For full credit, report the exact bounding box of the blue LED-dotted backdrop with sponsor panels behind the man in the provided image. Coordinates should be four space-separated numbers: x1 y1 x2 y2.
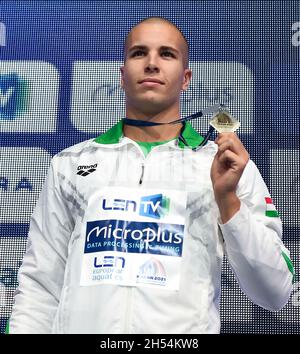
0 0 300 333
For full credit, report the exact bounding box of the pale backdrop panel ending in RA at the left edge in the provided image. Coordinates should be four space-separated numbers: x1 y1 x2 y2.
0 147 51 223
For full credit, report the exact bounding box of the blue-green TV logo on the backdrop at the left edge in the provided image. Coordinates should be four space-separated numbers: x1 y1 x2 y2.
0 73 29 120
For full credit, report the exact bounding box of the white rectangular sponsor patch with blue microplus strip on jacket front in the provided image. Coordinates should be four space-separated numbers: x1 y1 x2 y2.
80 187 187 290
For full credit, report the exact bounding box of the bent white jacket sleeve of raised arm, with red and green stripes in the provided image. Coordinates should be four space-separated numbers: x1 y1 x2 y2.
219 160 294 311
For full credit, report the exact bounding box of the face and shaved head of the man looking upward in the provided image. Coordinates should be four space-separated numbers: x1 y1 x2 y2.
120 22 191 114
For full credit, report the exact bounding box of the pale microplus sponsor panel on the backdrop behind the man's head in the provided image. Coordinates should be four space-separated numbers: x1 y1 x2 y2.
71 61 253 133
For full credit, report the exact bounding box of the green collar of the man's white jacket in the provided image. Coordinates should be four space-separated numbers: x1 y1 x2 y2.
94 120 204 148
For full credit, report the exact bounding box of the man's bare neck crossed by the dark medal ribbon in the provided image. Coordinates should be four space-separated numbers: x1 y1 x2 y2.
123 104 182 142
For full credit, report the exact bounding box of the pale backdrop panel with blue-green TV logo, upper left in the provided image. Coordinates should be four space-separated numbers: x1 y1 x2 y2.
0 61 59 132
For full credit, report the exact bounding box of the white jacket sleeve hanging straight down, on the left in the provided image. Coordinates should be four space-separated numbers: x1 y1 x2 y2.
9 157 73 333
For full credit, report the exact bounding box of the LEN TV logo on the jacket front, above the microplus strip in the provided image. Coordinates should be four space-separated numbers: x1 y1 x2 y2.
101 194 170 219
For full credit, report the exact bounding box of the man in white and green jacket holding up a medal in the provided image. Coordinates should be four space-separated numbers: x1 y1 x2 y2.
10 18 293 333
